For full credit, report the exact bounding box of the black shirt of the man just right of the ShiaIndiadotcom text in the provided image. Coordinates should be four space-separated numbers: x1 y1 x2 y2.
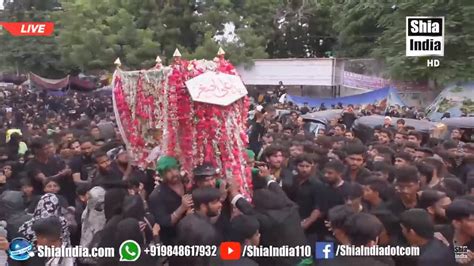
418 239 456 266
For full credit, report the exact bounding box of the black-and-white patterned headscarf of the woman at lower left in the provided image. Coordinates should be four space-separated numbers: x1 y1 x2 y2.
18 193 71 246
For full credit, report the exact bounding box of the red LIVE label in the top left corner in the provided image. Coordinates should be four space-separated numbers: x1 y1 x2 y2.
0 22 54 36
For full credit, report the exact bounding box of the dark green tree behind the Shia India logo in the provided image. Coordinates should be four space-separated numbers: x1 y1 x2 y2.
372 1 474 85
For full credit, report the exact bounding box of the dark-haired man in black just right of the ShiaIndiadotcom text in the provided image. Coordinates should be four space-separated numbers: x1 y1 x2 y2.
400 209 456 266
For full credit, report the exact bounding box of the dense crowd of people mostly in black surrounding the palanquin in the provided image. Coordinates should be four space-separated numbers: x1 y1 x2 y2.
0 85 474 266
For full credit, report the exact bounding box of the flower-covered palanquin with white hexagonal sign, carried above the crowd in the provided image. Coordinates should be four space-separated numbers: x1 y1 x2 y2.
113 52 251 197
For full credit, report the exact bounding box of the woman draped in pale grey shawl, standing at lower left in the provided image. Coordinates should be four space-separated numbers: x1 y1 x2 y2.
81 187 105 264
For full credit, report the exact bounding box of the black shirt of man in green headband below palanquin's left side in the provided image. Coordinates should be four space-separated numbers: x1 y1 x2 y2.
149 184 181 245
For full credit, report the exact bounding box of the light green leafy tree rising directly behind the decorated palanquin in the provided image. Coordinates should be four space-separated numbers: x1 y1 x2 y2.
59 0 266 71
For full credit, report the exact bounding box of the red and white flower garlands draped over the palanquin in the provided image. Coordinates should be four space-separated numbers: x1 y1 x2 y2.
114 57 251 198
